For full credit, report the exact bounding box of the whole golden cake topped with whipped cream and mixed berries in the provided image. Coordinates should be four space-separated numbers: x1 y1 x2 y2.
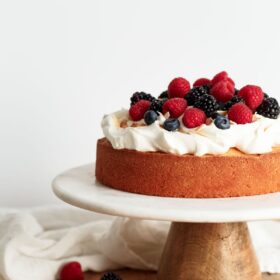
95 71 280 198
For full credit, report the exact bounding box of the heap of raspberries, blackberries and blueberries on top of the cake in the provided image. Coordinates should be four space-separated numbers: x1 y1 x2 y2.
129 71 280 131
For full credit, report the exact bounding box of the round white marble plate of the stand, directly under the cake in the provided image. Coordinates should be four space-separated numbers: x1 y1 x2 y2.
52 163 280 223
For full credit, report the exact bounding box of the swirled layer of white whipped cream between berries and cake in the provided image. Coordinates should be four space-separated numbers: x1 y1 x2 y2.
102 110 280 156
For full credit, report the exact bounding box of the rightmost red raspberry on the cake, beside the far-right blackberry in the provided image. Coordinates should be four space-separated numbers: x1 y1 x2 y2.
238 85 264 110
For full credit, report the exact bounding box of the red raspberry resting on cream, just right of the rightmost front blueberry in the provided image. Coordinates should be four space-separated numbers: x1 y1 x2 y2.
228 103 253 124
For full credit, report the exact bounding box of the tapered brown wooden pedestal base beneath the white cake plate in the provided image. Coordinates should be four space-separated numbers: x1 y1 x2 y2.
158 223 261 280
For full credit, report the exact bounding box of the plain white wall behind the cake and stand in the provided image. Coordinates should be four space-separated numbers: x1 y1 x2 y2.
0 0 280 207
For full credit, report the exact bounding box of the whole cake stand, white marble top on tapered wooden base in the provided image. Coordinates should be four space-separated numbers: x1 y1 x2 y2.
53 164 280 280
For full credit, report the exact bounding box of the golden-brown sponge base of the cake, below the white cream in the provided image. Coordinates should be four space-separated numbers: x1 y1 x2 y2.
95 138 280 198
